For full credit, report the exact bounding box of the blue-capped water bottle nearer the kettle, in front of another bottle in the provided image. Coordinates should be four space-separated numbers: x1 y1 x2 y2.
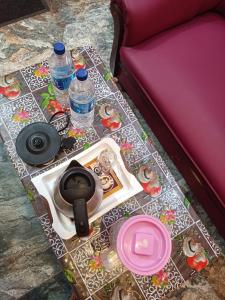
69 69 95 128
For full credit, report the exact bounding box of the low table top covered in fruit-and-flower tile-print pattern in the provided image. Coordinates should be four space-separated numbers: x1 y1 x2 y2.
0 47 220 300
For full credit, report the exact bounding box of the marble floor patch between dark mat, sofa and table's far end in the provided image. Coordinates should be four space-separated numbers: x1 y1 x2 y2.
0 0 113 75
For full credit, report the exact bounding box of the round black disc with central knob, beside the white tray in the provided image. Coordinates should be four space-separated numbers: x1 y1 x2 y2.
16 122 61 166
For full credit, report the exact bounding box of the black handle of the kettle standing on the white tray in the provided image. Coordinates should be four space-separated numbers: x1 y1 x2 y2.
73 199 89 237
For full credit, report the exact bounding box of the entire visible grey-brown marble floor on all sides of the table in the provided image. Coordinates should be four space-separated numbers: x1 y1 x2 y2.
0 0 225 300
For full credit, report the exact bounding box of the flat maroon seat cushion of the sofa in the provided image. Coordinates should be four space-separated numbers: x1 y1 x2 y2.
120 13 225 207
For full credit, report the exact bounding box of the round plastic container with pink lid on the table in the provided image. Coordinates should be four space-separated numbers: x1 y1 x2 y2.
103 215 172 276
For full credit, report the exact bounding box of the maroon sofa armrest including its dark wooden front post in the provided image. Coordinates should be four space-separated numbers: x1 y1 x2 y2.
110 0 222 76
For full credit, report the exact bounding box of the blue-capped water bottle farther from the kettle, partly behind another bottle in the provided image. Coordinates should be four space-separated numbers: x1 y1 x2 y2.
49 42 75 106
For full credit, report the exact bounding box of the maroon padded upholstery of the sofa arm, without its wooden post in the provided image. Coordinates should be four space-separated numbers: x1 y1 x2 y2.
111 0 221 46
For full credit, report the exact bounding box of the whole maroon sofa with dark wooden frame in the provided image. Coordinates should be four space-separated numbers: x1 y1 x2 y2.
111 0 225 236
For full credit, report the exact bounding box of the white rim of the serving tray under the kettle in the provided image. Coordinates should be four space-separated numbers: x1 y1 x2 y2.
31 138 143 240
